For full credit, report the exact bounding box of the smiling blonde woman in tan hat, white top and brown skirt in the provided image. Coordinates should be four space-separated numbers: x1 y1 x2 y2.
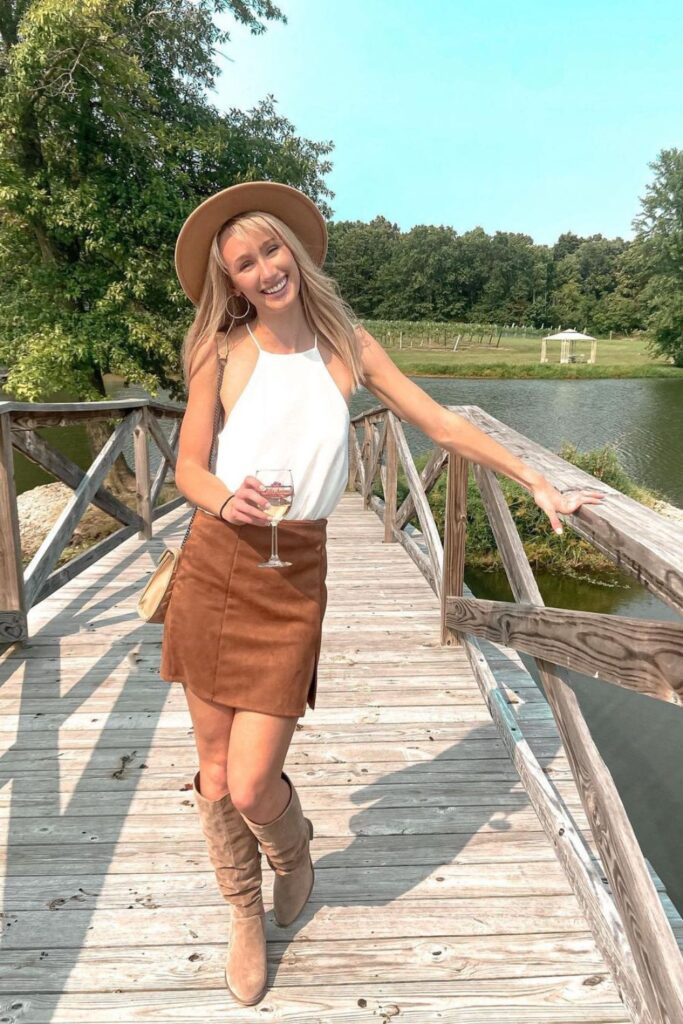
161 181 600 1005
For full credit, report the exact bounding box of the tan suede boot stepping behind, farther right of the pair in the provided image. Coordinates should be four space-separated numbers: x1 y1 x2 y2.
242 772 315 928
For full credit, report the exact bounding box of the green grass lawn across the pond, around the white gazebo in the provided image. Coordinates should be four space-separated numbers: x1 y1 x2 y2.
378 333 683 379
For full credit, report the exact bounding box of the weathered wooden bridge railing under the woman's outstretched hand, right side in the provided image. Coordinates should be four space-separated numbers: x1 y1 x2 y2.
348 406 683 1024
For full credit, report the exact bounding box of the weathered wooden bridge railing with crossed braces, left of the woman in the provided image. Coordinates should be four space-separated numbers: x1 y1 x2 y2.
0 398 185 644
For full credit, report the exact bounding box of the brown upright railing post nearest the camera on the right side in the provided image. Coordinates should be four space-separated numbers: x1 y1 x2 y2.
441 451 468 647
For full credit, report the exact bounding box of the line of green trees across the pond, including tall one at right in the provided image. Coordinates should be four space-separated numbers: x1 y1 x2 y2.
329 150 683 366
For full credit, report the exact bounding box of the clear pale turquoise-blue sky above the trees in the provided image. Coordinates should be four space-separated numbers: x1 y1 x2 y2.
209 0 683 244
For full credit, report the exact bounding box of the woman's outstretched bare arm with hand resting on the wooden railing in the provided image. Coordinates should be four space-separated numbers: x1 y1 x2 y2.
357 328 604 534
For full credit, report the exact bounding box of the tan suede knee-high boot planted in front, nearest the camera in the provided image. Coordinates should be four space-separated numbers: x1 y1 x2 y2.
193 772 268 1006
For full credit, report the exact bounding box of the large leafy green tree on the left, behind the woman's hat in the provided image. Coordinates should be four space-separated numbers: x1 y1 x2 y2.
0 0 332 487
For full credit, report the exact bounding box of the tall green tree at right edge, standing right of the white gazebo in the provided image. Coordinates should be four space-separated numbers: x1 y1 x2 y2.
629 148 683 367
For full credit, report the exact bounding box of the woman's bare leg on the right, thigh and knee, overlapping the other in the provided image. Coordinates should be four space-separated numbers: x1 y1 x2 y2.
227 708 298 823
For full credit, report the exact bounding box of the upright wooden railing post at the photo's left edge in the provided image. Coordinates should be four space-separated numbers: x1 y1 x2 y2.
0 413 29 644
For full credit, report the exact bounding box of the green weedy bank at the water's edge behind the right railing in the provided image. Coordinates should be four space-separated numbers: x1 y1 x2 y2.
373 442 664 586
